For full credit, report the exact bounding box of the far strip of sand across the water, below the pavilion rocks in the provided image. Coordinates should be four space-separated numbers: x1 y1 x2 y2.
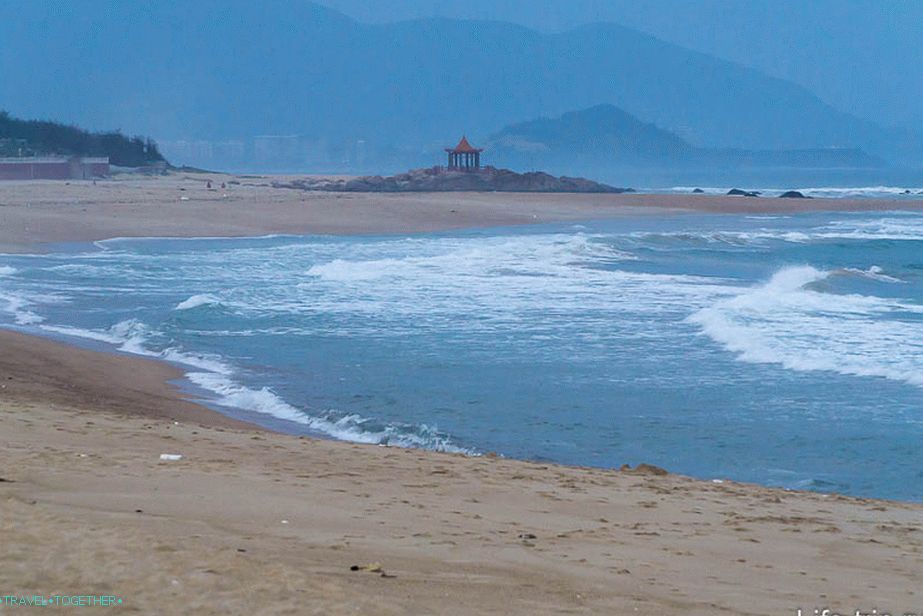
0 173 923 253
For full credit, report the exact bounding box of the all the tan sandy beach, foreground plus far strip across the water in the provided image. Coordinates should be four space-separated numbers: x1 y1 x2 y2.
0 174 923 616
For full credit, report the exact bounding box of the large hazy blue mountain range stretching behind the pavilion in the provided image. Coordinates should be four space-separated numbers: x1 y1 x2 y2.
0 0 923 171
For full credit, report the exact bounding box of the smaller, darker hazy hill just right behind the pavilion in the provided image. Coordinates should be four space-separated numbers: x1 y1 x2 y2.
484 105 884 174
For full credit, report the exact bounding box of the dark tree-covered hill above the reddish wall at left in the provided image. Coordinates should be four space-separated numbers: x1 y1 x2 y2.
0 111 164 167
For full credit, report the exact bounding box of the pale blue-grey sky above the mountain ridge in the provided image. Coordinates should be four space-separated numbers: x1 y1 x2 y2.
319 0 923 130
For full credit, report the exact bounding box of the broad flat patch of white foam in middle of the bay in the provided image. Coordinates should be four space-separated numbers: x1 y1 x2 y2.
296 234 727 337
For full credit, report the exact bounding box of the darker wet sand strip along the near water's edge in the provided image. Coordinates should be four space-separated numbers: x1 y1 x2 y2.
0 326 923 511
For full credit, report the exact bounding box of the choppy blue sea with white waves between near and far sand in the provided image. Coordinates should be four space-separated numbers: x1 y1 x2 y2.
0 195 923 501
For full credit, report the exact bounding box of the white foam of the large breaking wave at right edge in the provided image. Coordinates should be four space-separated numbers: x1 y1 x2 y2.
688 266 923 386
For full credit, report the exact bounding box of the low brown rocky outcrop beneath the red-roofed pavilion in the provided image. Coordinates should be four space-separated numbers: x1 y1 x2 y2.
273 167 634 193
